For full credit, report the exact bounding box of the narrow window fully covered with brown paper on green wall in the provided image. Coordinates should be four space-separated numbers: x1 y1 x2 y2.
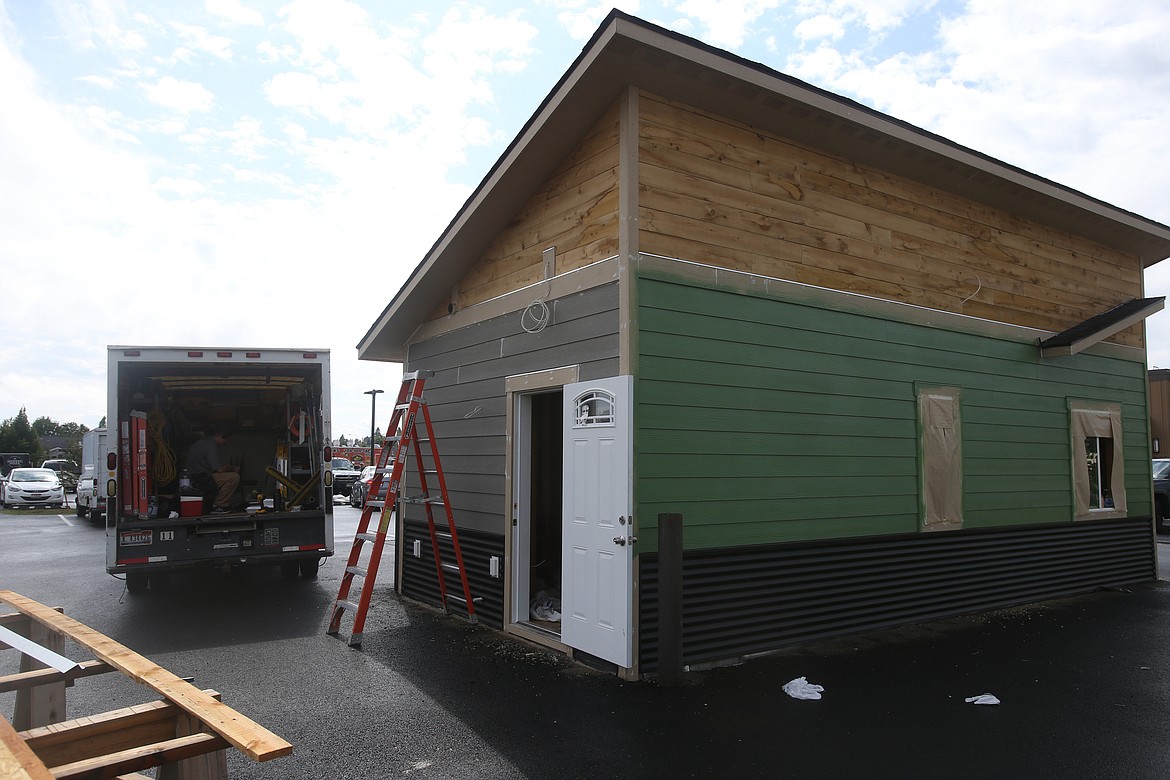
918 387 963 531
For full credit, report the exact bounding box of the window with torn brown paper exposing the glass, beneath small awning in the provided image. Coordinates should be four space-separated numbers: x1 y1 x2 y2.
1068 401 1127 520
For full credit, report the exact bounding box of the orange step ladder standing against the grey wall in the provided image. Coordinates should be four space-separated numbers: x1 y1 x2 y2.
325 371 481 647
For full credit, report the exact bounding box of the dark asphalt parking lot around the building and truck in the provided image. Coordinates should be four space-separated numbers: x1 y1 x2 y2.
0 506 1170 780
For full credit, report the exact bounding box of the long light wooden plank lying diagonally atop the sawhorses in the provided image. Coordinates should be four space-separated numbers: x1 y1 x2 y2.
0 591 293 771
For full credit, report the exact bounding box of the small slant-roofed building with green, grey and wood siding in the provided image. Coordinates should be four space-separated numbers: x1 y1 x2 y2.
359 12 1170 678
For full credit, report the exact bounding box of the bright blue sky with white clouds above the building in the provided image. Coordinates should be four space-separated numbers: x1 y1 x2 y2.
0 0 1170 436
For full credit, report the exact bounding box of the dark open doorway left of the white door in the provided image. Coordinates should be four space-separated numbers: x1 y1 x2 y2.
512 388 564 637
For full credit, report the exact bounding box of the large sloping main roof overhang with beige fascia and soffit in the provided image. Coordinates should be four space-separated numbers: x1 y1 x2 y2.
358 11 1170 361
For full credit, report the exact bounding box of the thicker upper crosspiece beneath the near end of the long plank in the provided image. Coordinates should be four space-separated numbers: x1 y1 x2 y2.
20 690 220 766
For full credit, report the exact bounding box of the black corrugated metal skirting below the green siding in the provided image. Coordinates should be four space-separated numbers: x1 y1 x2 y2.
638 517 1157 674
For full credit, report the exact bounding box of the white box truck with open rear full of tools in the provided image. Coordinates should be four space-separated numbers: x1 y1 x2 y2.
105 346 333 593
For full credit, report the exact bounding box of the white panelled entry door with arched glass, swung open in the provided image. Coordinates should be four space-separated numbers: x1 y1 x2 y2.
560 377 633 667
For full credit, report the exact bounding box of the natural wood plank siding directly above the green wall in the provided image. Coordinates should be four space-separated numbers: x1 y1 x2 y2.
638 92 1142 346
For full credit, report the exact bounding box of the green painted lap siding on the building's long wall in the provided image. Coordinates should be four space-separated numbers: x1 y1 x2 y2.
634 269 1150 551
